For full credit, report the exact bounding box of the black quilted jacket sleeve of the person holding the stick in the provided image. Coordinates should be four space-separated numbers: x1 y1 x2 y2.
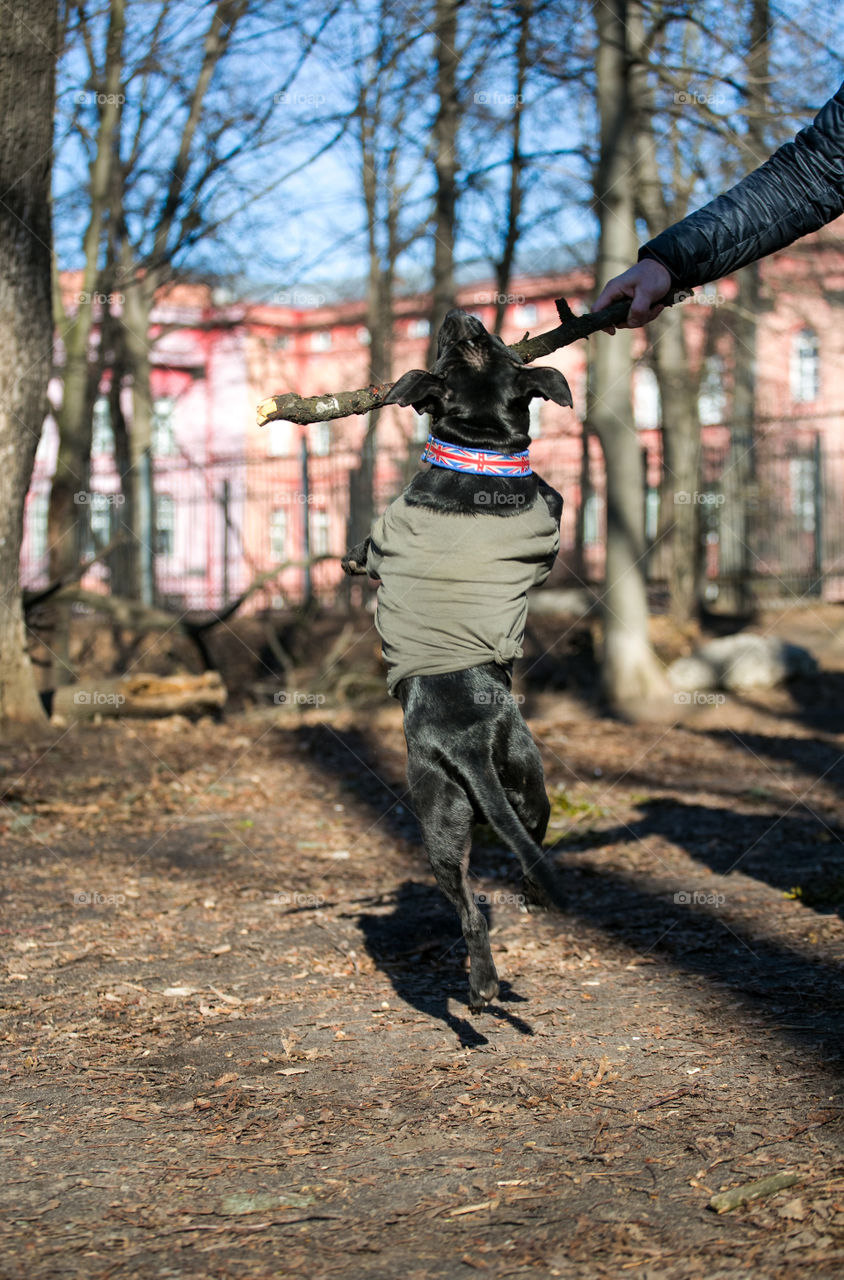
639 84 844 291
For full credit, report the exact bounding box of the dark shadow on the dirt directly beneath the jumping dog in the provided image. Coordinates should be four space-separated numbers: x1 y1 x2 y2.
356 879 534 1048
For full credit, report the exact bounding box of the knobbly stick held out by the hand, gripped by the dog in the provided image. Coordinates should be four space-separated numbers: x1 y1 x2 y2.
257 298 630 426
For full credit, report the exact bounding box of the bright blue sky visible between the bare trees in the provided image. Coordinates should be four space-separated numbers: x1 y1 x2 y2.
55 0 844 303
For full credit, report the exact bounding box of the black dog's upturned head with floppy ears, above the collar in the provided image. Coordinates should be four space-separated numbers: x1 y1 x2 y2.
384 310 572 453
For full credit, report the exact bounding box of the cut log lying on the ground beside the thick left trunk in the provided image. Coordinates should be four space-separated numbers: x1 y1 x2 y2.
53 671 227 721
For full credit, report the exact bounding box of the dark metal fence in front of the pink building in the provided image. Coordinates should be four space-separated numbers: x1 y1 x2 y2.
22 425 844 611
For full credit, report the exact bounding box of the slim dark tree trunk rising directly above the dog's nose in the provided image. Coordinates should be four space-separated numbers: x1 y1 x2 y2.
428 0 460 367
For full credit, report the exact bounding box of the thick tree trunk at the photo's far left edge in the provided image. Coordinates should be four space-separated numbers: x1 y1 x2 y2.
0 0 58 739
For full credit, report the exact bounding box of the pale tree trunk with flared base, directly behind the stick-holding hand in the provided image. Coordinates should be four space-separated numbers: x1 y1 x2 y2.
589 0 667 714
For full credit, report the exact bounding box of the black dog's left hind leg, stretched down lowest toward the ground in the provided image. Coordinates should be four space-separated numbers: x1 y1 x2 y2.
407 765 498 1014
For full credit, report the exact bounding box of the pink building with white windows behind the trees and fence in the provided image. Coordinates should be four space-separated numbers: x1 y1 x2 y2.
23 220 844 609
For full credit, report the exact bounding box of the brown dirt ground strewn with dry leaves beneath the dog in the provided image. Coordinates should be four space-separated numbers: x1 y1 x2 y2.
0 609 844 1280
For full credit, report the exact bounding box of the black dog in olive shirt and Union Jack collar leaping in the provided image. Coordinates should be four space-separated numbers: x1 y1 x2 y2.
343 311 571 1012
